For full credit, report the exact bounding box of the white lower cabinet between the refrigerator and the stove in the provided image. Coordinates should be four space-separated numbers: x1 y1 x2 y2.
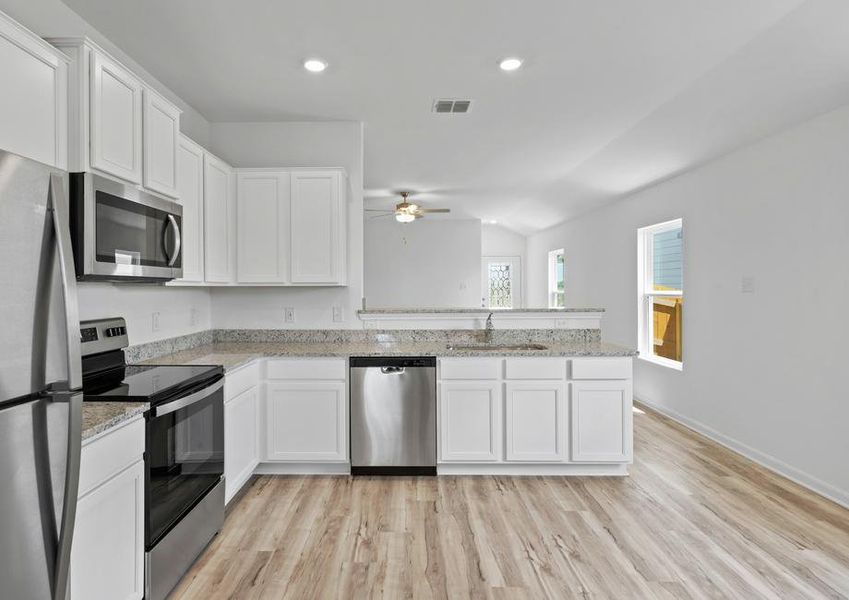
71 418 145 600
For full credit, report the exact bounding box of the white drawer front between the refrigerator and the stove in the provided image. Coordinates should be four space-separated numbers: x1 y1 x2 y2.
78 415 144 496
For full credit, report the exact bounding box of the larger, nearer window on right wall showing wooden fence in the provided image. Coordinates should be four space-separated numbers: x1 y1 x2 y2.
637 219 684 370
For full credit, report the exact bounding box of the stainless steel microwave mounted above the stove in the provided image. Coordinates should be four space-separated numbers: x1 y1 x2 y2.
69 173 183 281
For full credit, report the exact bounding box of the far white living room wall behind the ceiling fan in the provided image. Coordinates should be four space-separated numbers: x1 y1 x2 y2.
365 217 481 308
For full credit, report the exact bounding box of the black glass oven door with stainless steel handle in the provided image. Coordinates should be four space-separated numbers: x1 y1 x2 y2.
145 377 224 550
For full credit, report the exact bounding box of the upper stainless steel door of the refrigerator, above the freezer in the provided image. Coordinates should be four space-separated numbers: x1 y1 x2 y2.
0 151 79 406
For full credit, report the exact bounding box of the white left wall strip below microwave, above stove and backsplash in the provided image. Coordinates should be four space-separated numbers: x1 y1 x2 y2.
77 282 212 344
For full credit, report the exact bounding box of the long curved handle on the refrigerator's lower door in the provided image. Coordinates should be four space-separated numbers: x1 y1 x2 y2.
53 393 83 600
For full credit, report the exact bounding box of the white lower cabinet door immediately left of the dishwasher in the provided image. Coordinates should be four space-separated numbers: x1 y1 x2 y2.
266 381 348 462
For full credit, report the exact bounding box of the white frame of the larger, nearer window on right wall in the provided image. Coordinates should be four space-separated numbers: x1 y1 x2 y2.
637 218 686 371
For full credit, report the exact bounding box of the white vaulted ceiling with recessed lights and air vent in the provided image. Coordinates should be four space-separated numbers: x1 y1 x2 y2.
58 0 849 233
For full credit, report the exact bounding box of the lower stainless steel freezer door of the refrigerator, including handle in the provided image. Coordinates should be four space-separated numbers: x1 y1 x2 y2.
0 394 82 600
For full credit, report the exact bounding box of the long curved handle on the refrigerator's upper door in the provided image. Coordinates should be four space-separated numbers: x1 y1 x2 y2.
47 174 83 390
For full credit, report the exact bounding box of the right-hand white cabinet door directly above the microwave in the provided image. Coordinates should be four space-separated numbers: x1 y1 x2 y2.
142 88 180 198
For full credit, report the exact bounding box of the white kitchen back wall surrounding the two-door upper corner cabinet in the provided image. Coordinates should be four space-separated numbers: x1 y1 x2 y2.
210 121 363 329
